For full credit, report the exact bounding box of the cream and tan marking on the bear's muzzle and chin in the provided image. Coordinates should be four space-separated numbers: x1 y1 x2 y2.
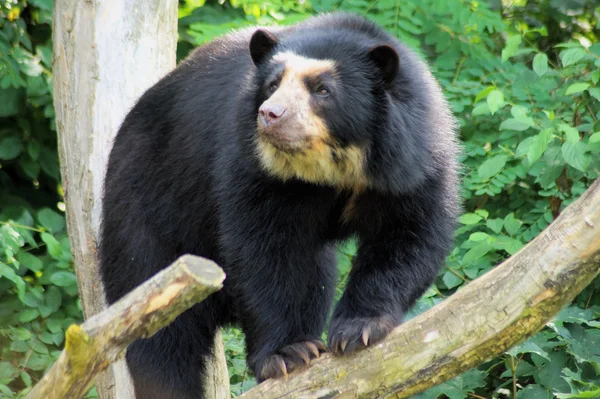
257 52 366 188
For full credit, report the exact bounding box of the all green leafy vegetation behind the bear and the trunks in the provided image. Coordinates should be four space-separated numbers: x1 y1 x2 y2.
0 0 600 399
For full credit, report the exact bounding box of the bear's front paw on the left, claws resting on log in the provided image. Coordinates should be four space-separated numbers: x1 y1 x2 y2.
256 339 327 382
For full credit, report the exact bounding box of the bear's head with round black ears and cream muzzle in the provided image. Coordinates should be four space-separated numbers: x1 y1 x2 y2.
250 29 399 190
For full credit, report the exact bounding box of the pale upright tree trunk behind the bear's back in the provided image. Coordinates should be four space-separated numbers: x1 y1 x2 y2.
53 0 229 399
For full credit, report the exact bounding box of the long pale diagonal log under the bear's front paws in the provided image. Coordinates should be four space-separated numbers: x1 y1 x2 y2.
240 180 600 399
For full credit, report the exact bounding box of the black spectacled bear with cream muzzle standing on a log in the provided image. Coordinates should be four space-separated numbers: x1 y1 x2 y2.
100 13 459 399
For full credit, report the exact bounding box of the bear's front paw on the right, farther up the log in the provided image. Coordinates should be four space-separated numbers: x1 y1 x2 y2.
327 315 400 354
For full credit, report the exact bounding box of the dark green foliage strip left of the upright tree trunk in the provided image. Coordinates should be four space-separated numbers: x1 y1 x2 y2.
0 0 90 398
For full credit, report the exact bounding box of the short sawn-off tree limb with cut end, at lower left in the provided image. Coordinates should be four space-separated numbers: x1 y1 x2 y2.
22 255 225 399
